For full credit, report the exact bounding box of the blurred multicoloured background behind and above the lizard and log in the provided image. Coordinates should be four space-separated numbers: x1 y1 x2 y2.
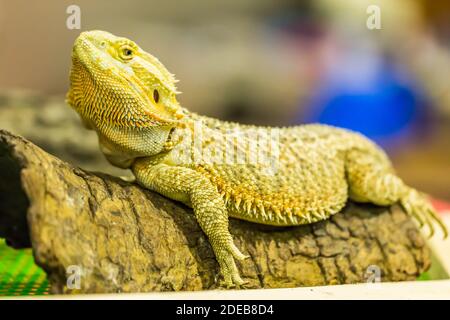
0 0 450 200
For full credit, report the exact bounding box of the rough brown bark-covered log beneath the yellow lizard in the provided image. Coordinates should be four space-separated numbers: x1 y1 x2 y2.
0 130 430 292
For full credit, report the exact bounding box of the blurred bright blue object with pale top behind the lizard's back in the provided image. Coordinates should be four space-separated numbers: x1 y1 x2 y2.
306 50 425 146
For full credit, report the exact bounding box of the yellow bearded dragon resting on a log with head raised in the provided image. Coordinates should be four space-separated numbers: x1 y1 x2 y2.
67 31 447 286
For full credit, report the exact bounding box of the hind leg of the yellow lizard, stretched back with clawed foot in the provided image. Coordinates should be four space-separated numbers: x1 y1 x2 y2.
346 152 448 238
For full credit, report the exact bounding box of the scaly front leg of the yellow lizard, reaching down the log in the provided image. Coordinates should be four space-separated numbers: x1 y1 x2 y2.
132 158 246 287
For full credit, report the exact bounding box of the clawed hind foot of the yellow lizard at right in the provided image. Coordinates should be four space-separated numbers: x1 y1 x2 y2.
400 187 448 239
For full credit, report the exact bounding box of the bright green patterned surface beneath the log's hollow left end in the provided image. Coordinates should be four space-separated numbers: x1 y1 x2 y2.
0 239 49 296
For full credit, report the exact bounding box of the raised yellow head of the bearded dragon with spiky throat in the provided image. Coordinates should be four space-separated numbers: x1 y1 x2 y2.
67 31 182 129
